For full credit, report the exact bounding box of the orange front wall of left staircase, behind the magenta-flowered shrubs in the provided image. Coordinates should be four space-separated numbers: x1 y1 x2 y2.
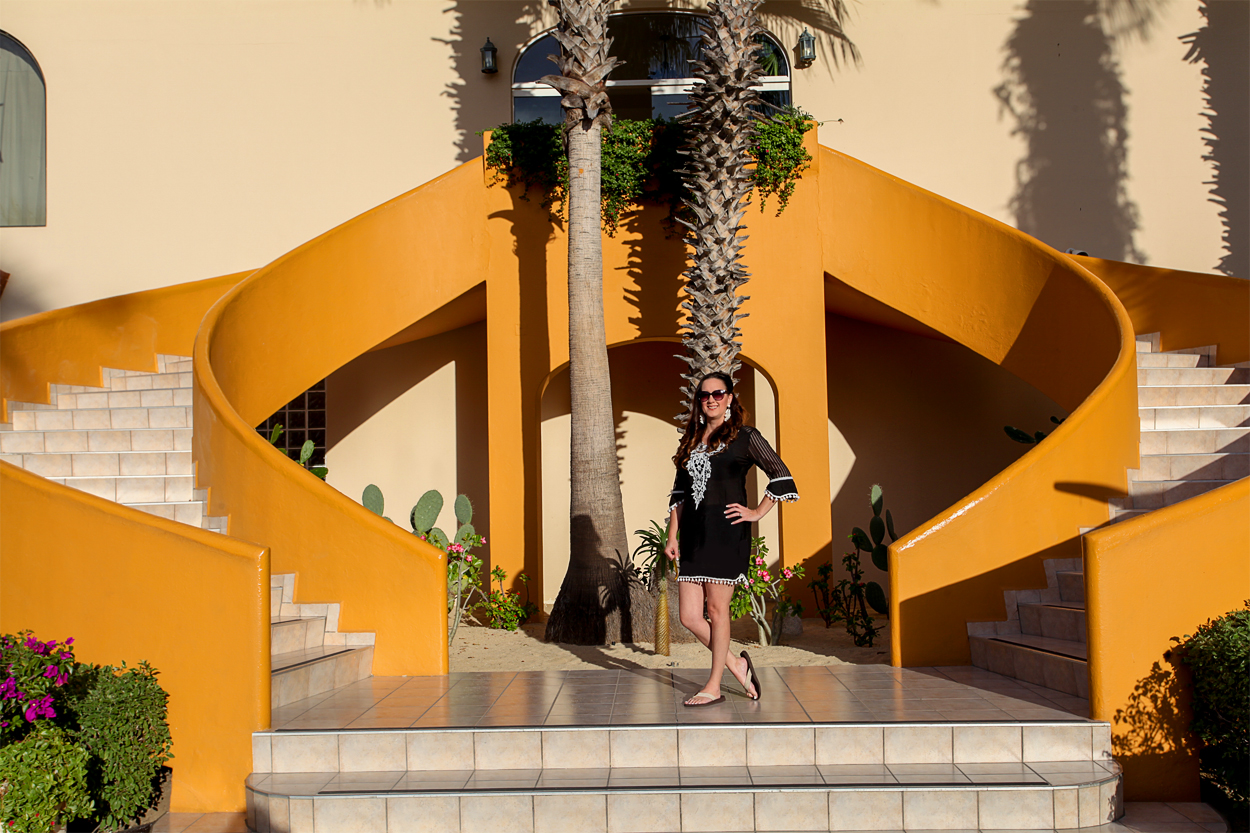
0 463 269 813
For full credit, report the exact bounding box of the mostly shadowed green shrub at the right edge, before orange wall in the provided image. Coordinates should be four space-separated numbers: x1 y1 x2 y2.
1176 600 1250 802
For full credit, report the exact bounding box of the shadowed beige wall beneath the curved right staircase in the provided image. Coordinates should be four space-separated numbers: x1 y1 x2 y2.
825 314 1078 584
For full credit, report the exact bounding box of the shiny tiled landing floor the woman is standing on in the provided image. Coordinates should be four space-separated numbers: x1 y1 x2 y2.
273 665 1088 730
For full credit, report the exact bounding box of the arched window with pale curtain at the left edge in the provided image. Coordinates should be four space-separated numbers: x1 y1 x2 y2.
0 31 48 226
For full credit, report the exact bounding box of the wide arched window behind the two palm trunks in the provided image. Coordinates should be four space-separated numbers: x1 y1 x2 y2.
513 11 790 124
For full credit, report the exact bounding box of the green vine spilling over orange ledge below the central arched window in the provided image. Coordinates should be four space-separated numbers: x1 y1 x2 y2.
475 108 814 236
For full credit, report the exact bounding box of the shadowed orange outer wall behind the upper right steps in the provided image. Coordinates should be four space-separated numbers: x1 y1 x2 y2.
1074 258 1250 364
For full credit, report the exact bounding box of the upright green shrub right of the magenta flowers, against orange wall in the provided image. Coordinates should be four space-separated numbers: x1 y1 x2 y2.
75 663 173 830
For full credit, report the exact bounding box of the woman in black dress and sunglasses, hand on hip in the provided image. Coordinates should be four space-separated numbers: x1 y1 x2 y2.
664 373 799 705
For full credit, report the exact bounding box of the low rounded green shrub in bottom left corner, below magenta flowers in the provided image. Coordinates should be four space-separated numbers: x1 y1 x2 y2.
0 722 93 833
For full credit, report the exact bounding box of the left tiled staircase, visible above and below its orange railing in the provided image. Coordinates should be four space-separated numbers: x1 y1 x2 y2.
0 355 374 707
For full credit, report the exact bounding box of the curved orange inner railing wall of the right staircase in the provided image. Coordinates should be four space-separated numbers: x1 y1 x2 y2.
815 148 1138 665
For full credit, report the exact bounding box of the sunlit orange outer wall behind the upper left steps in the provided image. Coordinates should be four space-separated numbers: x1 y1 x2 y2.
0 271 249 423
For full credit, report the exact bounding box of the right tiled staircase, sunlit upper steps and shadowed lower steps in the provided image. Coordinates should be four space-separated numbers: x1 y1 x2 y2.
968 333 1250 698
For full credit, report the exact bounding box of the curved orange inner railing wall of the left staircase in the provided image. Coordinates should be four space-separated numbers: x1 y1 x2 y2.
193 160 489 674
